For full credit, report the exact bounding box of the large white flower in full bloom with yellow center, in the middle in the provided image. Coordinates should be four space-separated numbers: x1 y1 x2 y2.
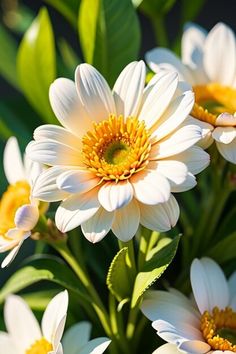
26 61 209 242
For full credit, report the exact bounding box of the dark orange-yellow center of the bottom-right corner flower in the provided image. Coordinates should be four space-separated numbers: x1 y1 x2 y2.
201 307 236 353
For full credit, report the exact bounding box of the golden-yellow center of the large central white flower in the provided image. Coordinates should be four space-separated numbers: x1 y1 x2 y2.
82 115 151 182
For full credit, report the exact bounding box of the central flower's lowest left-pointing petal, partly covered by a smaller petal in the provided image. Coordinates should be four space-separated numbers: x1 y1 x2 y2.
32 166 68 202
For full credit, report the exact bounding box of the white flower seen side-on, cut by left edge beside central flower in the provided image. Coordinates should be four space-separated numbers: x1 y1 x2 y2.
0 137 42 267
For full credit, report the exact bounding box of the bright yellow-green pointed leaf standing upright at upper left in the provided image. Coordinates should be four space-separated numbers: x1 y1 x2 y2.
17 9 57 123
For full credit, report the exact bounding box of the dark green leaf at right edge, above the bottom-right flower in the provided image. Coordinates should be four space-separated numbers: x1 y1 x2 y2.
207 232 236 264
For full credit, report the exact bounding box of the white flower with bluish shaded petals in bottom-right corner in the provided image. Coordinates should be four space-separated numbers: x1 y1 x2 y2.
142 258 236 354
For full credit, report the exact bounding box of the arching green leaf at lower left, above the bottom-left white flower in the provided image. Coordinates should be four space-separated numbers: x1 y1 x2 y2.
0 256 86 303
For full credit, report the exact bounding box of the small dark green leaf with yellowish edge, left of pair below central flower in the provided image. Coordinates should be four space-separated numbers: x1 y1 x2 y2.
107 247 134 301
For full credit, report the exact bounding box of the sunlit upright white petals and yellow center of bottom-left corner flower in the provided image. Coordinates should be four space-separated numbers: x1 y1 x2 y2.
0 291 68 354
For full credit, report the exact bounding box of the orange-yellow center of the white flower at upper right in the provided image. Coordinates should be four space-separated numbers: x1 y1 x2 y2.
191 83 236 125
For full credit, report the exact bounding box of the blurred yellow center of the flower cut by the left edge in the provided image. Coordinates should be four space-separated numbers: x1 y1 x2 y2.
0 181 30 236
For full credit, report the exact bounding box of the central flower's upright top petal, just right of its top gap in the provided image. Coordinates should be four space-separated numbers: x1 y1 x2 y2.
113 60 146 117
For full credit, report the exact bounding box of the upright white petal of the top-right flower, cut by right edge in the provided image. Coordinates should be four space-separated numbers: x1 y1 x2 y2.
204 23 236 86
